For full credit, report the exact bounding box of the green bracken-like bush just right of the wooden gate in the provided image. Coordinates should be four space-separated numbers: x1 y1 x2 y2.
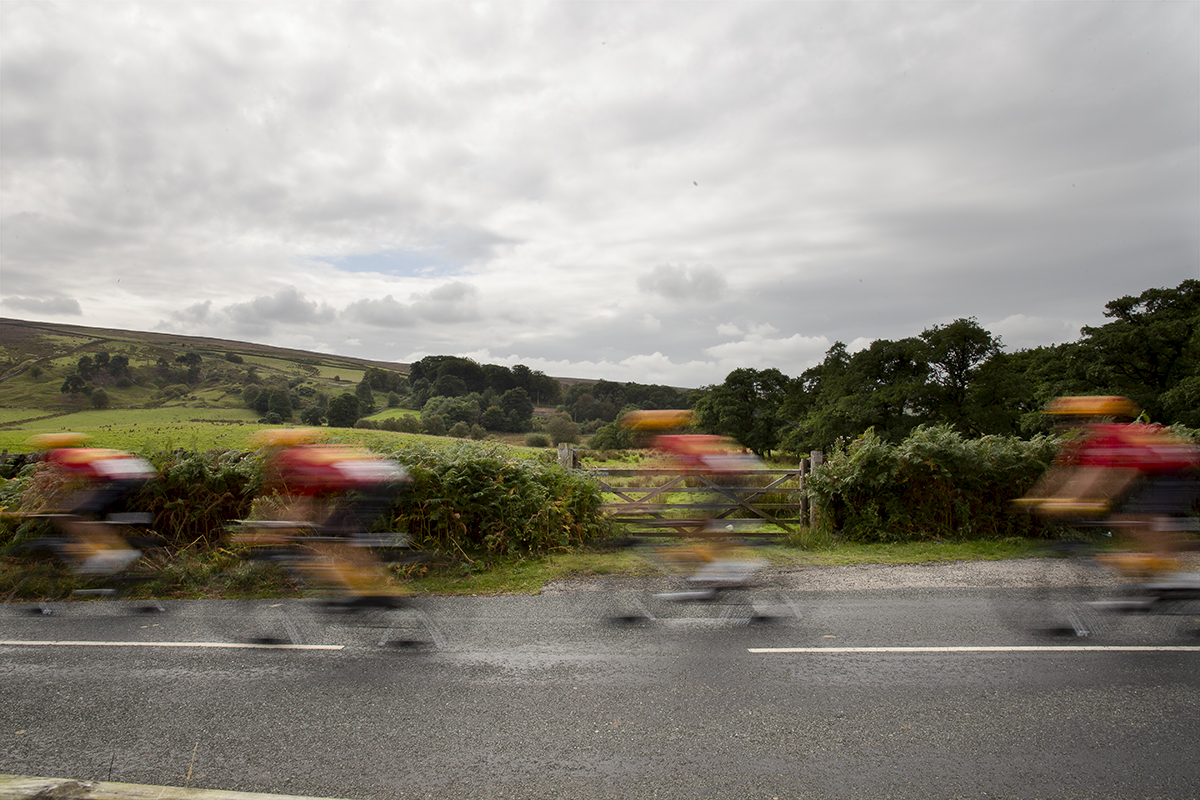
809 426 1058 542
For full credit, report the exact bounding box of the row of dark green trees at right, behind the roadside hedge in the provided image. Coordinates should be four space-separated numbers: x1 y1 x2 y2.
695 281 1200 455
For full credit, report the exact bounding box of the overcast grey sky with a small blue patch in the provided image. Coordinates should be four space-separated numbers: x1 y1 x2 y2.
0 0 1200 386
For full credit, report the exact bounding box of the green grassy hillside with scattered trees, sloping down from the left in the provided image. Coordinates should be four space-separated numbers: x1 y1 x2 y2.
0 319 420 450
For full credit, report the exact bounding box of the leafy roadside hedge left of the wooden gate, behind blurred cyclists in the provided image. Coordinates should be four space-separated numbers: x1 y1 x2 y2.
0 441 606 558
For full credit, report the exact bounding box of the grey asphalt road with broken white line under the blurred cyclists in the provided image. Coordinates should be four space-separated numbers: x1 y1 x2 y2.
0 588 1200 800
